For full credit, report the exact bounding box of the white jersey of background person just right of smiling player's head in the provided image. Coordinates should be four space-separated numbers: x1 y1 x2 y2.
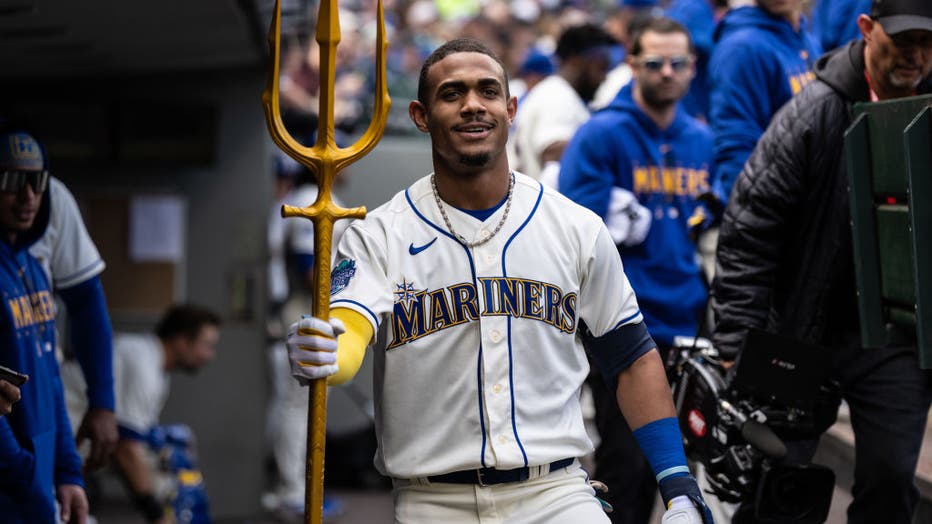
510 75 590 179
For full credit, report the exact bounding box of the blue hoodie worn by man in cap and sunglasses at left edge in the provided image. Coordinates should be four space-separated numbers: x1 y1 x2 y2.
0 199 84 524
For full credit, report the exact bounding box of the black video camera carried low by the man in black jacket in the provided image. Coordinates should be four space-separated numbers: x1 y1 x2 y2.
667 331 837 523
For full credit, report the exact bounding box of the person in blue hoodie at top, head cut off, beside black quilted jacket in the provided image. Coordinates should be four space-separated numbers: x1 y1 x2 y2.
709 0 822 202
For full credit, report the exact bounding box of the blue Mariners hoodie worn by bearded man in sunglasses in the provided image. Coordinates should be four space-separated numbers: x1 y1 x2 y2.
559 84 713 345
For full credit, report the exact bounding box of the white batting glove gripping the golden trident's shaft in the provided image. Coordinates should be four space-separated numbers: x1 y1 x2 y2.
285 317 346 386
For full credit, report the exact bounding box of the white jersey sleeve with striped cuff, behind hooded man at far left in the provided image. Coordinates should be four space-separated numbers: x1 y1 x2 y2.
29 177 104 289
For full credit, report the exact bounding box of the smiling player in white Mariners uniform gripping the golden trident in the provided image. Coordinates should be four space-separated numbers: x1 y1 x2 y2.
288 39 711 523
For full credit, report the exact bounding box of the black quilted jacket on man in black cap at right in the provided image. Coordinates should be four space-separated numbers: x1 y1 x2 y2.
712 41 932 357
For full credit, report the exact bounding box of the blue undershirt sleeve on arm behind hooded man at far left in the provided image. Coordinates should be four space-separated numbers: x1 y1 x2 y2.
58 276 116 411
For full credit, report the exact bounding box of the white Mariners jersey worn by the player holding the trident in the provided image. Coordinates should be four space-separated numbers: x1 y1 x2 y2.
331 173 642 478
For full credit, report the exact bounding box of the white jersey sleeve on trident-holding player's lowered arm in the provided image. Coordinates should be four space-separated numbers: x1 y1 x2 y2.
579 225 644 337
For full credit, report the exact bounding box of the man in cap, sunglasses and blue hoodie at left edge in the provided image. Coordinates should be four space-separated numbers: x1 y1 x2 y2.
0 127 88 524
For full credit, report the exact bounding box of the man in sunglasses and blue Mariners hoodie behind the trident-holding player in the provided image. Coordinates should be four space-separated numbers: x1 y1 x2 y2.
559 18 713 523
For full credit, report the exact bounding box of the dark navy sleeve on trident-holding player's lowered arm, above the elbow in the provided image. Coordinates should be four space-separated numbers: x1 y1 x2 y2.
580 322 657 392
